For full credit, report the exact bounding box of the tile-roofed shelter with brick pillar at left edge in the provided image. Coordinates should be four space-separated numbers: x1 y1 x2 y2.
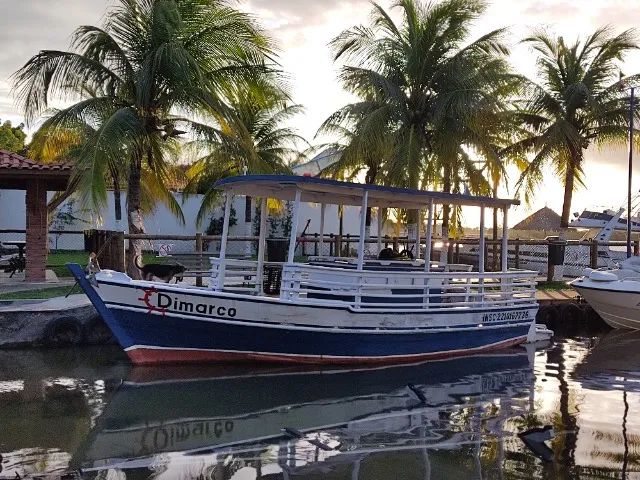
0 150 71 282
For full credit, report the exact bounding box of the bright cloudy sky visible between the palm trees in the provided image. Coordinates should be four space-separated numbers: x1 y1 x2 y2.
0 0 640 224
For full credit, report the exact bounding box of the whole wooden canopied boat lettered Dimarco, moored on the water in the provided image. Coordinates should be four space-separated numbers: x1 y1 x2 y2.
68 175 538 364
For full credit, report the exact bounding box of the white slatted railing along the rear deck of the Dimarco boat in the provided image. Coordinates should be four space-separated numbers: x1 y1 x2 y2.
280 264 537 310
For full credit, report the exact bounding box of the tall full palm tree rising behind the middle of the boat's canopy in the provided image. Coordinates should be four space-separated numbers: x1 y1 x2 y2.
332 0 514 236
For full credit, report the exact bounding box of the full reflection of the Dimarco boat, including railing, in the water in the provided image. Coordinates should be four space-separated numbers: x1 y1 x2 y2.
74 348 534 479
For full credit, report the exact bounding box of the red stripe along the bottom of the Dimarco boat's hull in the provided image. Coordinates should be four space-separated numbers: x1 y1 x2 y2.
127 337 526 365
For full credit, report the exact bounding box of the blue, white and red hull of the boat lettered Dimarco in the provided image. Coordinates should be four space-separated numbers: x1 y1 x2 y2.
67 266 537 364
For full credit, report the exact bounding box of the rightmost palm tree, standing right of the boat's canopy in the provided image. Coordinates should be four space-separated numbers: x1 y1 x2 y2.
507 27 640 228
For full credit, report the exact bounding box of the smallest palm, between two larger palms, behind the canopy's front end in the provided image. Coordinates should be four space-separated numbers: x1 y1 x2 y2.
185 85 306 225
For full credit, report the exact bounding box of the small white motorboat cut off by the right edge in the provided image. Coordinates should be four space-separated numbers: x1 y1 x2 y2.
570 257 640 330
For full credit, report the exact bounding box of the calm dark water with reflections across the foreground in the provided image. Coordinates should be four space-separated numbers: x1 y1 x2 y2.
0 332 640 480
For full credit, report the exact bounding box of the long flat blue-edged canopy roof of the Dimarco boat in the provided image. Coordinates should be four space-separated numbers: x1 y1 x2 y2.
214 175 520 209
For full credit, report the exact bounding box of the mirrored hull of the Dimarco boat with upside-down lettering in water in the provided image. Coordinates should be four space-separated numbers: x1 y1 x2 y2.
71 347 534 478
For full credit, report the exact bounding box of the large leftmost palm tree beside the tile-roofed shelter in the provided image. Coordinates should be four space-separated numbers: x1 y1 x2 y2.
14 0 271 275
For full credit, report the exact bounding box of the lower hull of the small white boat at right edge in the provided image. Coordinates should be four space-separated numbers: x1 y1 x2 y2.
571 279 640 330
